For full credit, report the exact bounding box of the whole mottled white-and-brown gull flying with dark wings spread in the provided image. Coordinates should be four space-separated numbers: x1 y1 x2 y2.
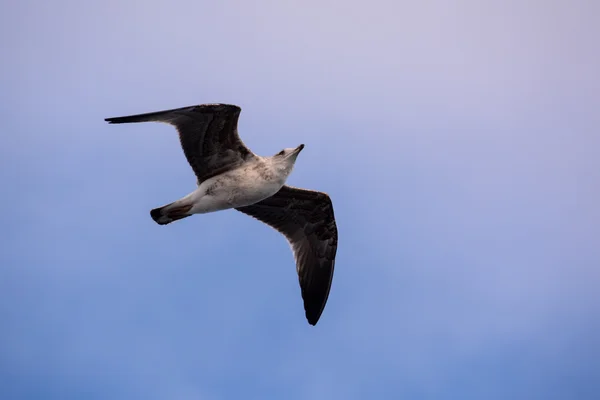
105 104 338 325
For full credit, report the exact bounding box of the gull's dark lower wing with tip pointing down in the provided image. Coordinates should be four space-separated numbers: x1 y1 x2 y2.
237 186 338 325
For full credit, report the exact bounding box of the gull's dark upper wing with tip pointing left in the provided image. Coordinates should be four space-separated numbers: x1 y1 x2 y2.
105 104 254 184
